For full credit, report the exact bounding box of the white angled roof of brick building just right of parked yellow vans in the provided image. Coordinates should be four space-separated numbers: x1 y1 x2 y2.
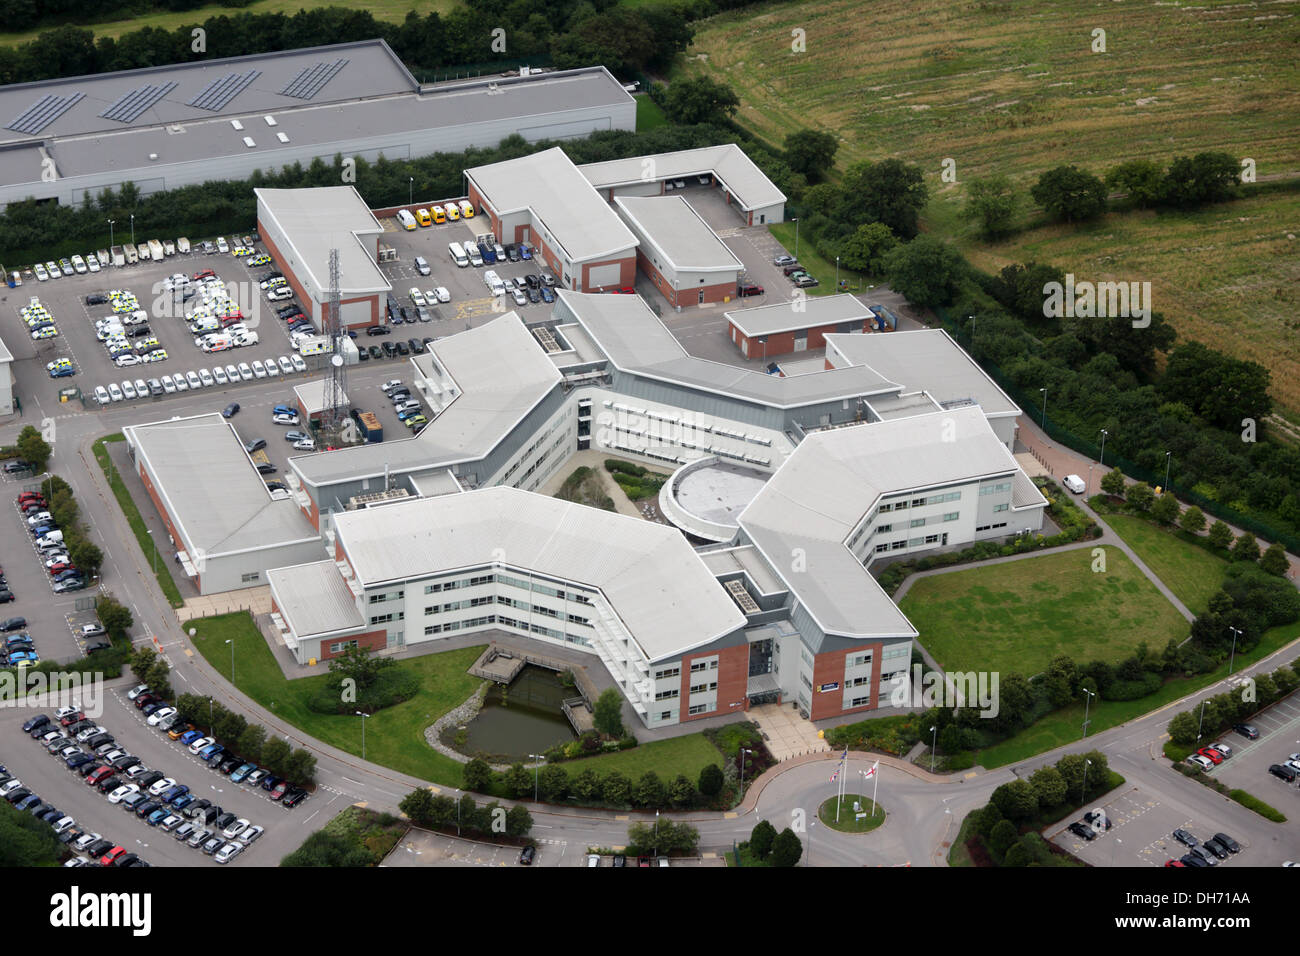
465 146 637 263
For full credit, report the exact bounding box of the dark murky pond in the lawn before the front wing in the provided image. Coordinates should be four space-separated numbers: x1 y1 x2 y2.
442 665 577 763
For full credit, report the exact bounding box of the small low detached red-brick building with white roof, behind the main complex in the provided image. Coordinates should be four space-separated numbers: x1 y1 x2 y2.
723 295 875 368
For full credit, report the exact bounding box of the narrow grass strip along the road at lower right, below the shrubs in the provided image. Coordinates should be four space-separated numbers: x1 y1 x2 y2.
975 622 1300 770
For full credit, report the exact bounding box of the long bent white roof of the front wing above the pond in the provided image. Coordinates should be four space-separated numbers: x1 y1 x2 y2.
334 486 745 661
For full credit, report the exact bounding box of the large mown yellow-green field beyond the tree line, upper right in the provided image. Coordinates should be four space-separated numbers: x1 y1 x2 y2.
681 0 1300 410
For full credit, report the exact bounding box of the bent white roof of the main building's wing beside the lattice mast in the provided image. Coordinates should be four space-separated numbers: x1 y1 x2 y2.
291 316 561 485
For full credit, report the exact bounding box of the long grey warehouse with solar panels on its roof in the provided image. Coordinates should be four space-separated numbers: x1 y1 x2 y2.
0 39 636 207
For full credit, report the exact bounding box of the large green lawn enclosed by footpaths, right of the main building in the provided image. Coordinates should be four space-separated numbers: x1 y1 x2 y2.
900 548 1187 676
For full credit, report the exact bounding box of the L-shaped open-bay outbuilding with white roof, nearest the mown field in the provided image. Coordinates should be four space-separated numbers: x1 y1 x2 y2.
579 143 785 226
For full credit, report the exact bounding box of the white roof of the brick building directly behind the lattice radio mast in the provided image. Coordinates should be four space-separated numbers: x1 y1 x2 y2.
254 186 393 293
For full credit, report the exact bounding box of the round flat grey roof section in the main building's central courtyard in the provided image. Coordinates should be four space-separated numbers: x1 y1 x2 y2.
659 455 771 541
